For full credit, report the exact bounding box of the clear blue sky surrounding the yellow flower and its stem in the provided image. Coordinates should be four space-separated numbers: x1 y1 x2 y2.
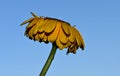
0 0 120 76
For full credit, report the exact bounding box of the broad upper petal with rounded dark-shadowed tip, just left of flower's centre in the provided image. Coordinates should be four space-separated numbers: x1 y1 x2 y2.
45 20 57 33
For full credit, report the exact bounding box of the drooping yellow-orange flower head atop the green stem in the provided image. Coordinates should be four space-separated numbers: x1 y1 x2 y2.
21 13 85 53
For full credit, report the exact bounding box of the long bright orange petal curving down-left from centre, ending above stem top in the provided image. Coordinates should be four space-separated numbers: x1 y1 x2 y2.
48 22 61 42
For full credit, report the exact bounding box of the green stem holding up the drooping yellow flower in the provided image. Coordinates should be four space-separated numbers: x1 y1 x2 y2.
39 43 57 76
